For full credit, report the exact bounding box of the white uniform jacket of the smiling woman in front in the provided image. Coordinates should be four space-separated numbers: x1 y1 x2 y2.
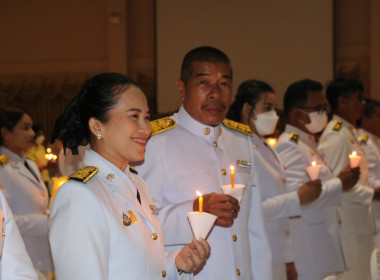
49 149 187 280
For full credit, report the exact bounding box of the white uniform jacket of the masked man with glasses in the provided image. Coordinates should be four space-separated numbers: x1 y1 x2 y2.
275 125 345 275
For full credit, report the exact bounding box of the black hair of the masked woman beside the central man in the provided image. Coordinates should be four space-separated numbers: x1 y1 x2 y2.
227 80 274 122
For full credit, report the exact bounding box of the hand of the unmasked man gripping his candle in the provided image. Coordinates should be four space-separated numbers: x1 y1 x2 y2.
193 193 240 227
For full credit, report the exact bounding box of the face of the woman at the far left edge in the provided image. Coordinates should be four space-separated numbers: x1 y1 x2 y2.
1 114 35 155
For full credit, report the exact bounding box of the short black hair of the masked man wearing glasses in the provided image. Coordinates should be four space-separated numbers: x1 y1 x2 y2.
284 79 323 118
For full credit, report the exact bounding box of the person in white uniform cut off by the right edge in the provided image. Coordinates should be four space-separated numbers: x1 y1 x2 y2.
359 99 380 249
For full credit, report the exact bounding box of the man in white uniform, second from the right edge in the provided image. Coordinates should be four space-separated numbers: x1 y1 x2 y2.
318 78 374 280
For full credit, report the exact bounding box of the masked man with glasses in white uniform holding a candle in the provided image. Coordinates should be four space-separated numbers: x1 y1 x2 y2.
276 79 360 280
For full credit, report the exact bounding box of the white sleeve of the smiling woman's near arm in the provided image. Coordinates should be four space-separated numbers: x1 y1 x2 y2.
49 182 110 280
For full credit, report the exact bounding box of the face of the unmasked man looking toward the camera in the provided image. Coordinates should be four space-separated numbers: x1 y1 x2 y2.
177 61 232 125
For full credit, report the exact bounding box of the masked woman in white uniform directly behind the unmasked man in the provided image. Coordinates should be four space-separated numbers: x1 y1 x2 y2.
227 80 330 280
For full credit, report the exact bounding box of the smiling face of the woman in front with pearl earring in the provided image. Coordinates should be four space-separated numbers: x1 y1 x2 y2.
94 86 152 169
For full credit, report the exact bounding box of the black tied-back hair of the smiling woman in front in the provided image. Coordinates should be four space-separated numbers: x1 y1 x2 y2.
51 73 137 154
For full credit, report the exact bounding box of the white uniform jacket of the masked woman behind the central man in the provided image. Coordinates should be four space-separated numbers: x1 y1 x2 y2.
250 133 301 264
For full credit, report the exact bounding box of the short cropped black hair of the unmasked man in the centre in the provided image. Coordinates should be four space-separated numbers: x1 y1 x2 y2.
181 46 232 84
